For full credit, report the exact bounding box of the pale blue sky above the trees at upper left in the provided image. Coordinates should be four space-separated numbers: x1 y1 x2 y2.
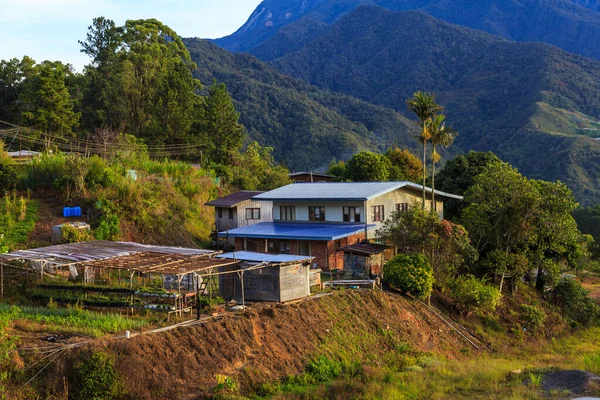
0 0 261 71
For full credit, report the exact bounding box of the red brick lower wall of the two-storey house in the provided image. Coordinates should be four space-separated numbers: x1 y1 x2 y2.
235 232 365 271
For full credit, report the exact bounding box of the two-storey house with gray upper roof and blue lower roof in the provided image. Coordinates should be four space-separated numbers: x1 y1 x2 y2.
219 182 462 270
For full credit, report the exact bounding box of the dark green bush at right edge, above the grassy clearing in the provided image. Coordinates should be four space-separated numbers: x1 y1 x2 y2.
552 277 600 325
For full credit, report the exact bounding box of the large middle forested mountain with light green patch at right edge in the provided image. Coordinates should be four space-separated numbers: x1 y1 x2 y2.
273 6 600 204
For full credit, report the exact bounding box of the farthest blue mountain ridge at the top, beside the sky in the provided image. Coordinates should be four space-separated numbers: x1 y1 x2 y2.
215 0 600 60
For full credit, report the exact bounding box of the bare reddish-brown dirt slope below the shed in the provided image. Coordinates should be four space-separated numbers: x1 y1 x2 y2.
46 291 480 399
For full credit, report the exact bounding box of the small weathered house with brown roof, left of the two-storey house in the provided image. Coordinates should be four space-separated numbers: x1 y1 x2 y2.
206 190 273 244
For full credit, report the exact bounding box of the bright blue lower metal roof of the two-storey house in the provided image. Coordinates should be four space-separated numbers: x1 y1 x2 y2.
219 222 375 241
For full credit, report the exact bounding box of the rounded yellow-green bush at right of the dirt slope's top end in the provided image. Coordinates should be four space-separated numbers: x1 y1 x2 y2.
447 275 501 315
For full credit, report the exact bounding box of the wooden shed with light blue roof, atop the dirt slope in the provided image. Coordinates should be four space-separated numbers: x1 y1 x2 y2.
217 251 313 303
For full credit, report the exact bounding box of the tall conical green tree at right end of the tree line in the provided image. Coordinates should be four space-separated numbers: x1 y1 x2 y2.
201 82 245 165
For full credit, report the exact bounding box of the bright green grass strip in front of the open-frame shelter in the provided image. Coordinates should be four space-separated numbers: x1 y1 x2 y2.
0 304 148 337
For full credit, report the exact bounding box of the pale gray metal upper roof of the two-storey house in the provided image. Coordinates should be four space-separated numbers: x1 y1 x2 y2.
254 181 462 201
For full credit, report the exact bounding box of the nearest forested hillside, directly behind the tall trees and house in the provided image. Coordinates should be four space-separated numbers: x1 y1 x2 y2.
184 39 417 170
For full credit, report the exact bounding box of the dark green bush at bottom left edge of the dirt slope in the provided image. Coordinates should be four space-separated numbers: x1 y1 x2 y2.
74 352 124 400
